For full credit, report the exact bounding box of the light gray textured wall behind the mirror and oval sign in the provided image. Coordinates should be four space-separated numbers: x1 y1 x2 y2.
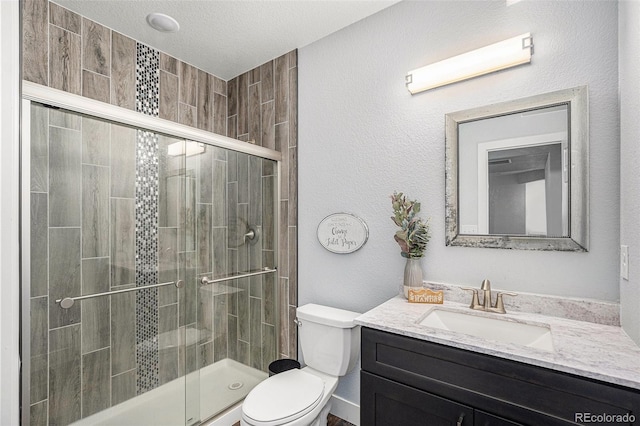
299 1 620 401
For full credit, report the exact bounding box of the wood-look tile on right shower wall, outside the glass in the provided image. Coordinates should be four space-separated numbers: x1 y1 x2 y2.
227 50 298 358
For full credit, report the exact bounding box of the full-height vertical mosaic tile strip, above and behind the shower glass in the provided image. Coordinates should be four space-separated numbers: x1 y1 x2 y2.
135 43 160 394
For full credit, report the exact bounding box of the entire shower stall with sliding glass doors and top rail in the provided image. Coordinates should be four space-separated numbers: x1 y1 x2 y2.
21 85 281 425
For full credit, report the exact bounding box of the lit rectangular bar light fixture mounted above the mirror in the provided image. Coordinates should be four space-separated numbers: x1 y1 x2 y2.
405 33 533 94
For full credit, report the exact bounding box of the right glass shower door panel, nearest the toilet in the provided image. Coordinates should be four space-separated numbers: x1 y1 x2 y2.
192 146 278 419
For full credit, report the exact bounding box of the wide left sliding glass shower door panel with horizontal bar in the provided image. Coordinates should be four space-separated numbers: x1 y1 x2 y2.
25 104 194 425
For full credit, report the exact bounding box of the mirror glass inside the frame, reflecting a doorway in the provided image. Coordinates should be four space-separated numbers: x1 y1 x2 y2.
458 104 569 237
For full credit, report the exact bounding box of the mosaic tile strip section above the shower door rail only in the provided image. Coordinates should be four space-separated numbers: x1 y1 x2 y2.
136 43 160 117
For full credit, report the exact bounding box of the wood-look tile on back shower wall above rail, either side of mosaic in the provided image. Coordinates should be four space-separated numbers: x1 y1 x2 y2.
22 0 227 135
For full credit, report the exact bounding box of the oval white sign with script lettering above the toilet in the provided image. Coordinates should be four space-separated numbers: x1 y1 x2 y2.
318 213 369 254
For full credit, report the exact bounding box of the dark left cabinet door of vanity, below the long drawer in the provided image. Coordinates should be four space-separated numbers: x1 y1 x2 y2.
360 371 473 426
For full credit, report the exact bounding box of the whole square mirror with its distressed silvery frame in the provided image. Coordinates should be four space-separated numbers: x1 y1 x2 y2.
445 86 589 251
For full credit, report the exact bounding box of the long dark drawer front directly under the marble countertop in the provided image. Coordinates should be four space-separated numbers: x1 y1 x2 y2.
362 327 640 425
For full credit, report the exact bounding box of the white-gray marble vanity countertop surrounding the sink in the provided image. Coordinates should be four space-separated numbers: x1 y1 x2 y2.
356 296 640 389
